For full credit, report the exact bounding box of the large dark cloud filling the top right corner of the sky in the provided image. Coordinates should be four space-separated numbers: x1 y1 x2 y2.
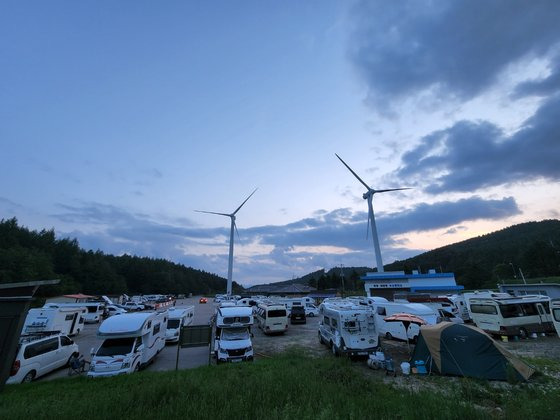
350 0 560 109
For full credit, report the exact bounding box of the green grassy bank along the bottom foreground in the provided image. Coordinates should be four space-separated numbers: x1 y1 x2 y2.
0 352 560 420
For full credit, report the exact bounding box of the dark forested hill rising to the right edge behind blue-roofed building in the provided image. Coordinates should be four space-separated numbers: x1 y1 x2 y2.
385 220 560 289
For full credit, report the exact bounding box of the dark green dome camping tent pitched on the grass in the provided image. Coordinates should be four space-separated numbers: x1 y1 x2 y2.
411 322 535 380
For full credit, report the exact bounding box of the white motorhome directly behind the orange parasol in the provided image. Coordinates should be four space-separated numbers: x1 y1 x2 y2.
359 296 438 342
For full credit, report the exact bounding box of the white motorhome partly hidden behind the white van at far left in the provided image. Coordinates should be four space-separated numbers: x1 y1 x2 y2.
23 307 87 336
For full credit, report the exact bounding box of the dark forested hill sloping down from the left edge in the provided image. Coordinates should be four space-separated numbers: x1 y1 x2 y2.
0 218 234 296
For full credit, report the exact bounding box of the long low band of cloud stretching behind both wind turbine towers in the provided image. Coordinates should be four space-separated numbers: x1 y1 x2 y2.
49 197 519 284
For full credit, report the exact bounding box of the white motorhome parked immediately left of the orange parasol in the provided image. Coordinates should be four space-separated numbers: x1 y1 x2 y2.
318 300 378 356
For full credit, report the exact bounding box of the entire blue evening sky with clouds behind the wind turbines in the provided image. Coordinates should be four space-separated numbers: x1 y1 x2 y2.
0 0 560 286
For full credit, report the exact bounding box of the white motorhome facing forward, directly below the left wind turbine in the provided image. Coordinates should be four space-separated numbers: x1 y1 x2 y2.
214 306 254 363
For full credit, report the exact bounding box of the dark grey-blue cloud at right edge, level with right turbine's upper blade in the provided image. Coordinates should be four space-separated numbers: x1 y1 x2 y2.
397 95 560 194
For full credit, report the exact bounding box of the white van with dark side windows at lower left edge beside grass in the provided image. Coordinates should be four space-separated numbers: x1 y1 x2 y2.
6 333 79 384
